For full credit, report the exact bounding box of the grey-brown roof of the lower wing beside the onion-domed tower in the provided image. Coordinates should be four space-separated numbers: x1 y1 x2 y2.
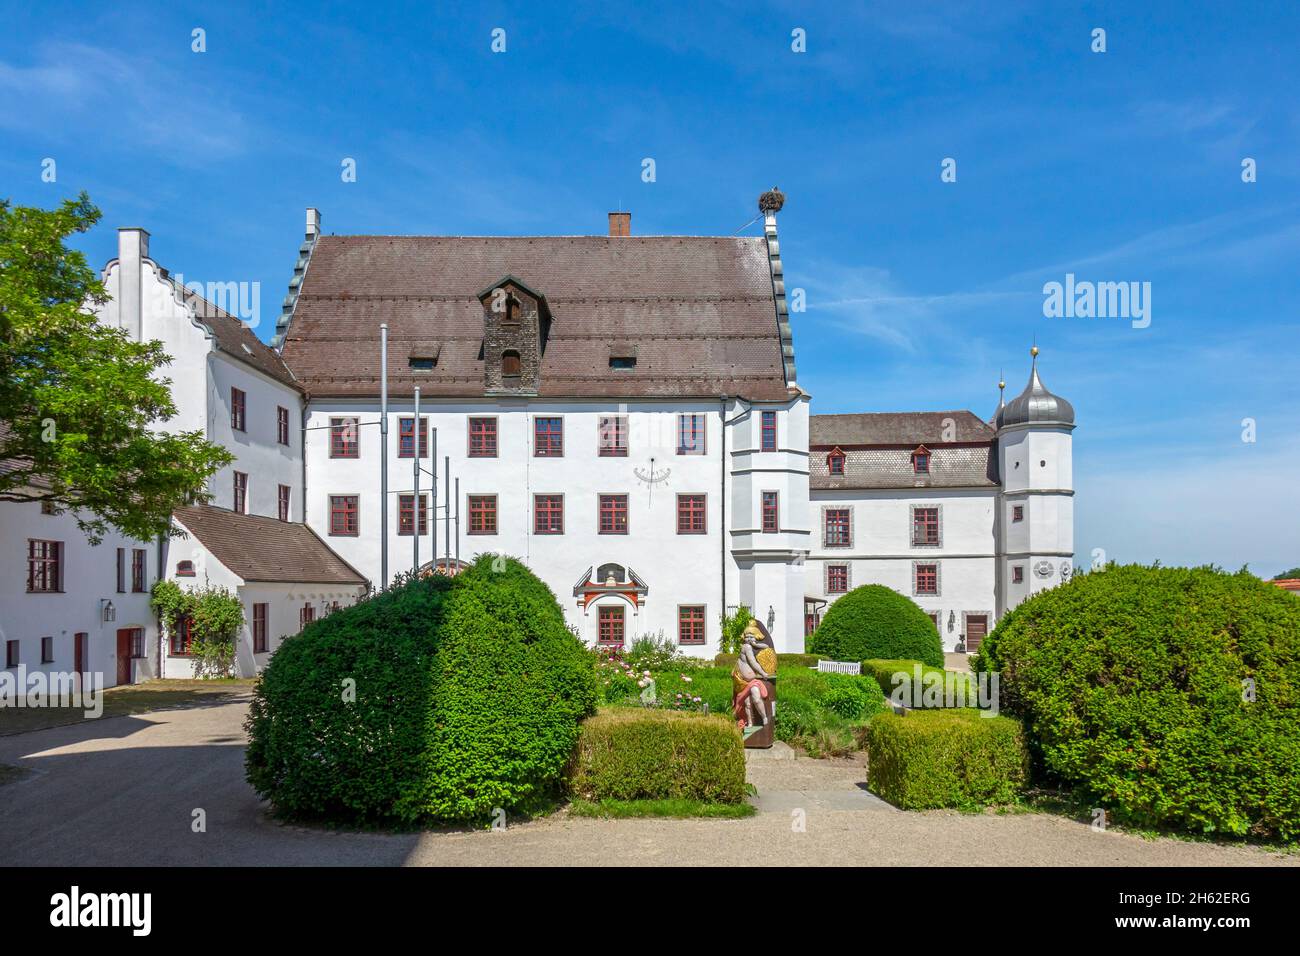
809 410 998 490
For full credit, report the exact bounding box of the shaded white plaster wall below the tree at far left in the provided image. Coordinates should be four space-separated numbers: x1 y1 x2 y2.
0 502 157 687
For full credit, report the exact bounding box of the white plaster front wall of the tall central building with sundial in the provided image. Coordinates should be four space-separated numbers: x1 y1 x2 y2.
306 399 807 654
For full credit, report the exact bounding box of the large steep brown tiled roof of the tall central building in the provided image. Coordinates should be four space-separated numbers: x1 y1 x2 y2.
282 235 789 401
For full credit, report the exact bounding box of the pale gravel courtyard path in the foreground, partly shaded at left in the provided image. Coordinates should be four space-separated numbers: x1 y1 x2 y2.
0 700 1300 866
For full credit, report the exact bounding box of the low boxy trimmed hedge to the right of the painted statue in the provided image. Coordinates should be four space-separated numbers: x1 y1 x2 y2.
865 709 1030 810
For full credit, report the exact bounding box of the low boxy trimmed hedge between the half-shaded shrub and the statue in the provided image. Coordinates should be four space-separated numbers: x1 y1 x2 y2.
569 708 745 804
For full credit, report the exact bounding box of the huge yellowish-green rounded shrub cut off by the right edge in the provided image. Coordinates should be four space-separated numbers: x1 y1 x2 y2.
976 566 1300 840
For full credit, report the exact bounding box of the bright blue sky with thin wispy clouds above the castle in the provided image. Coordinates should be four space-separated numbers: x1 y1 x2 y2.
0 0 1300 575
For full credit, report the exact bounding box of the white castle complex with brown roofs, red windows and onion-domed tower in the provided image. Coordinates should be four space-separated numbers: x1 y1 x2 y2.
0 194 1074 684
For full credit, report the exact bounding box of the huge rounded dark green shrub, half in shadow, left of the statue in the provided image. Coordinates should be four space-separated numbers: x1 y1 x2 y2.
247 555 595 823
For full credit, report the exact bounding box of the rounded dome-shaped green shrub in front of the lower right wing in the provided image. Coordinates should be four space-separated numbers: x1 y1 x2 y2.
807 584 944 667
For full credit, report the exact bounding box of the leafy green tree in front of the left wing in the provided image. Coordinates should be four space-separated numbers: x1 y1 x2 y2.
0 193 233 542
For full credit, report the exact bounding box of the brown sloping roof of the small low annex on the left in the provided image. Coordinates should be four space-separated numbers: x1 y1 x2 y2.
173 505 365 584
